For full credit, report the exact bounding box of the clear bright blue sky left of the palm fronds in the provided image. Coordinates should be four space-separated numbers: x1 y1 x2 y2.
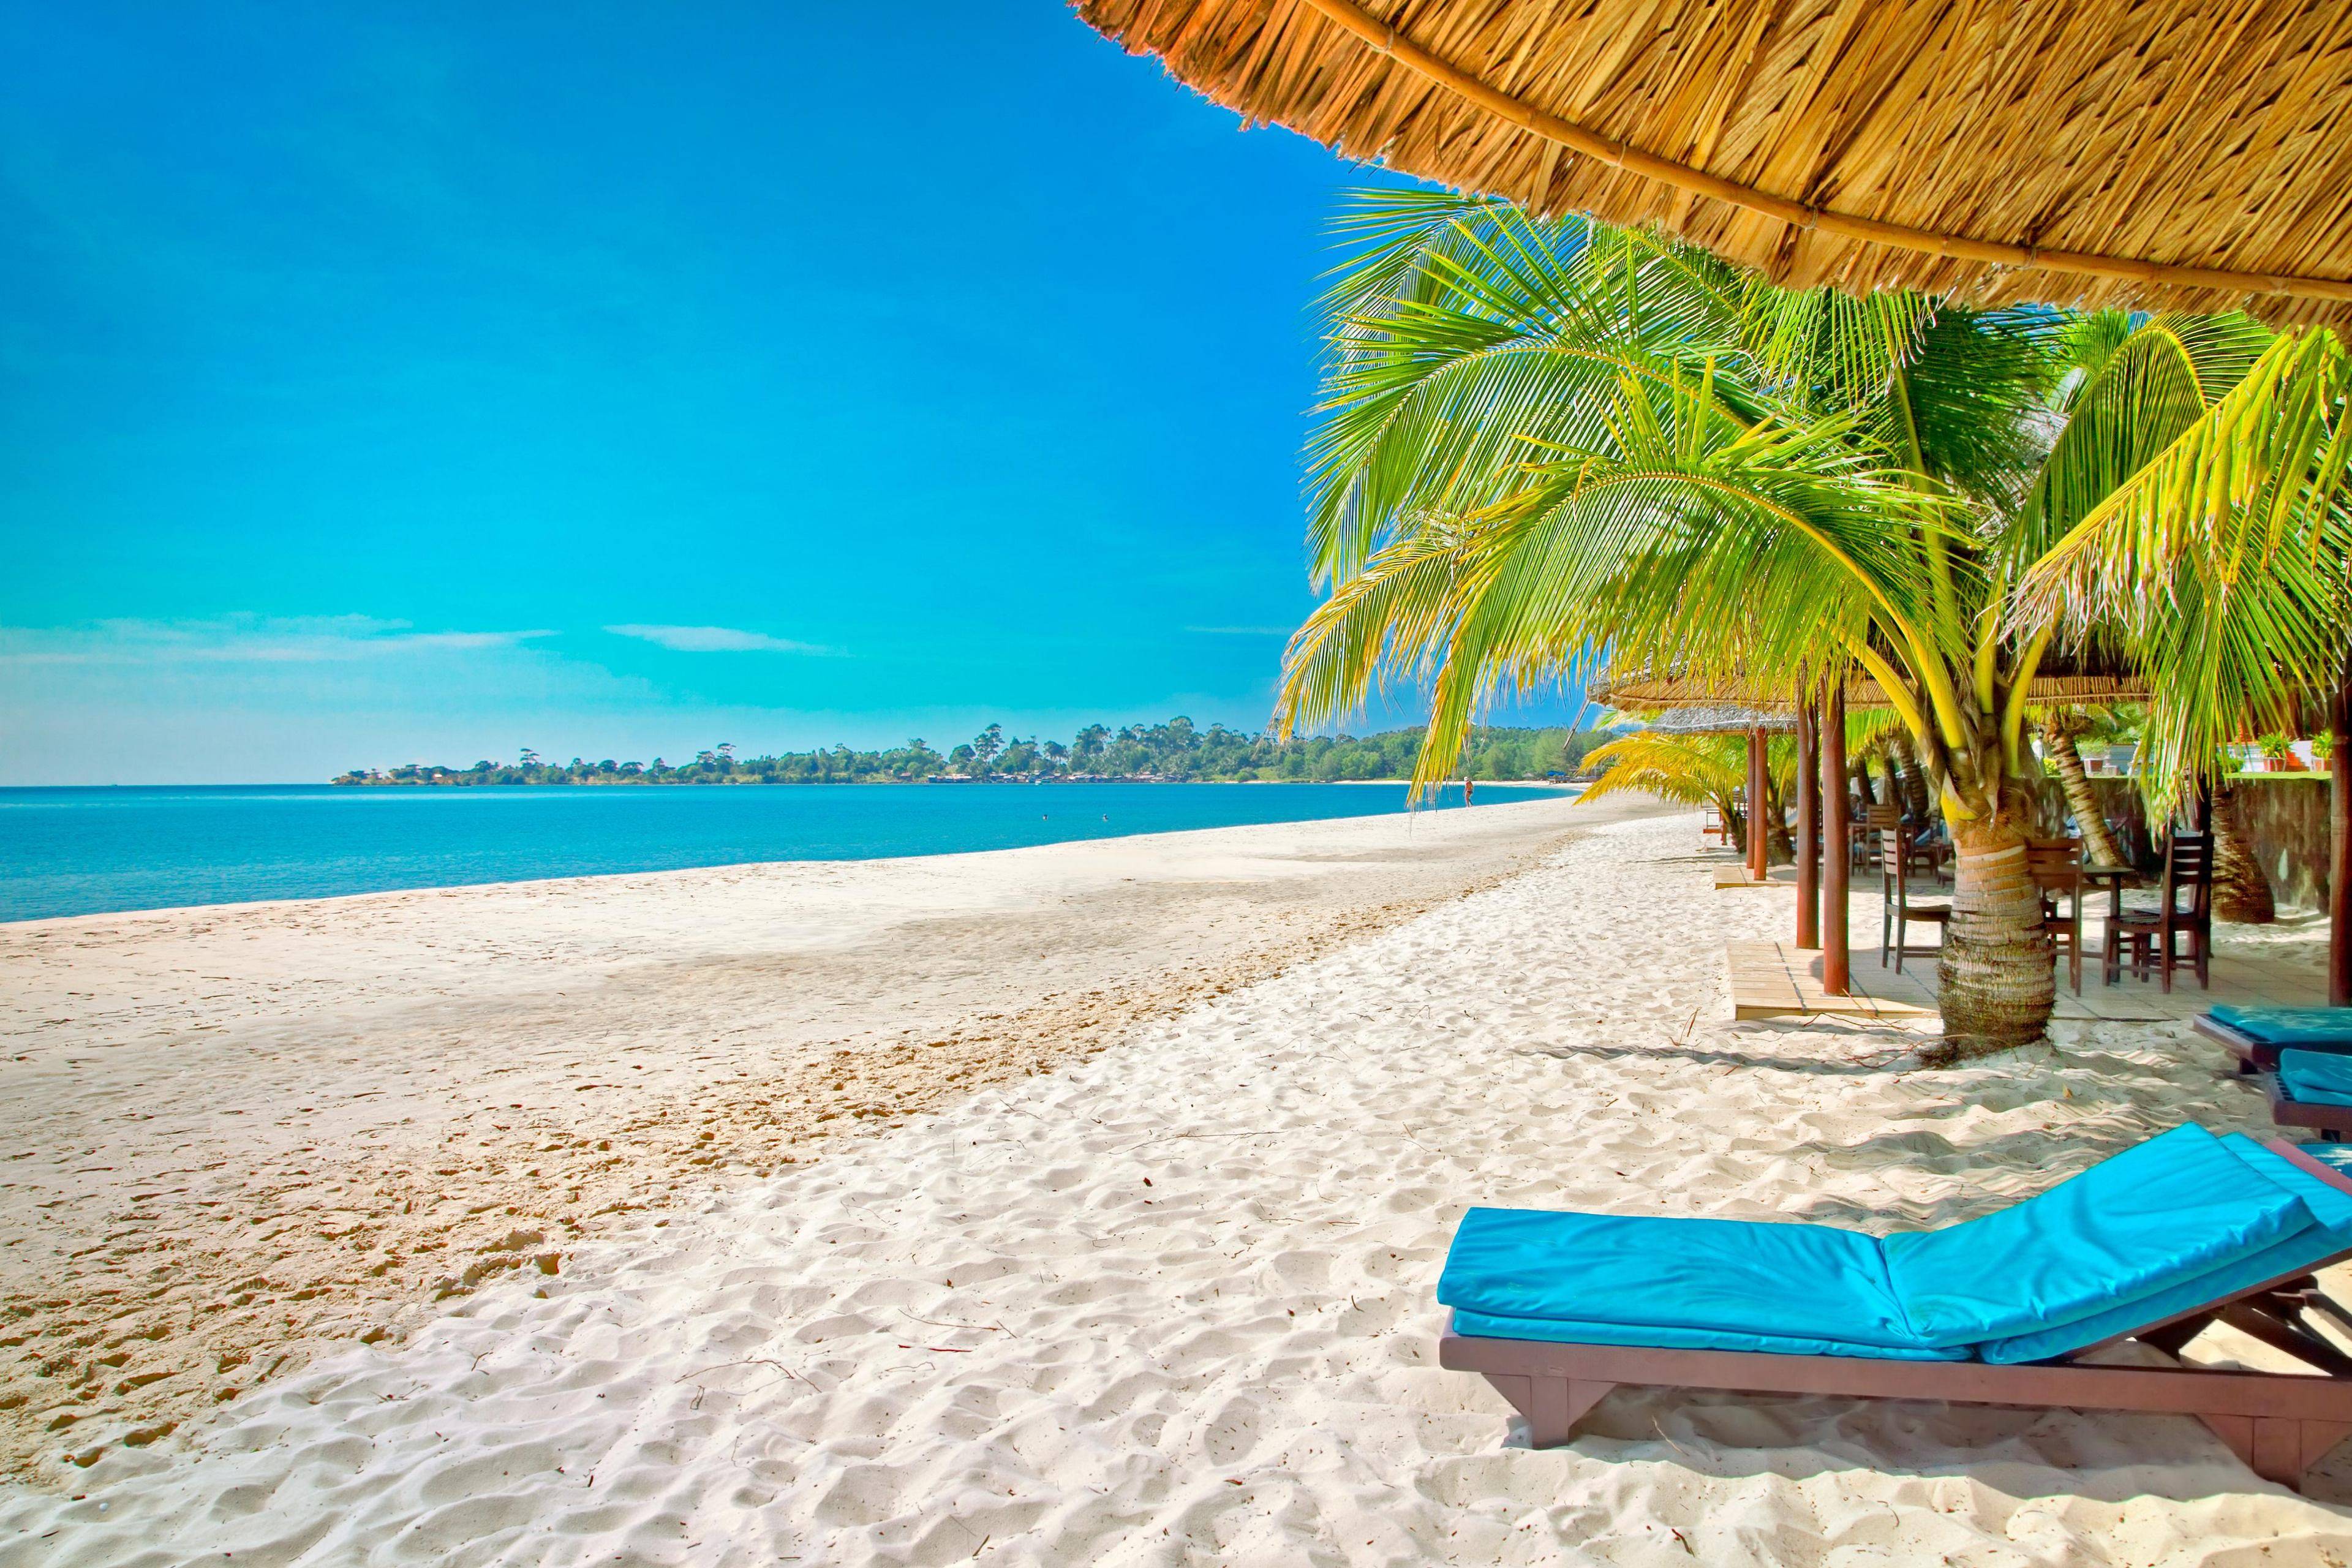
0 0 1580 783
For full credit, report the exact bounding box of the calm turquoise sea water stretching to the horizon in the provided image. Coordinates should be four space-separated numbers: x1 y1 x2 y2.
0 785 1555 919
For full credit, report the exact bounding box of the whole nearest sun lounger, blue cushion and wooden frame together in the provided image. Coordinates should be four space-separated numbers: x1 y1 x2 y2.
1437 1126 2352 1486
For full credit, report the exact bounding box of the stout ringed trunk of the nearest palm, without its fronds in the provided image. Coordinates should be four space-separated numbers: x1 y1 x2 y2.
1936 809 2058 1055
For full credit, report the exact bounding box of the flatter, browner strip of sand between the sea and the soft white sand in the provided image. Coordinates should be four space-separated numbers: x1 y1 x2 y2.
0 802 1646 1483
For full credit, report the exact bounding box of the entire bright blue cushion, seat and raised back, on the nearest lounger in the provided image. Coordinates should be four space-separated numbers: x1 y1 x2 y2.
1437 1126 2352 1363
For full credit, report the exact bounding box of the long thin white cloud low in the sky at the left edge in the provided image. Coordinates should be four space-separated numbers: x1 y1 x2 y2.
0 616 552 665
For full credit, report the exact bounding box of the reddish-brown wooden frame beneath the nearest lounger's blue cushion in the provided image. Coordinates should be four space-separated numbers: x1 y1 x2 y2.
1437 1142 2352 1486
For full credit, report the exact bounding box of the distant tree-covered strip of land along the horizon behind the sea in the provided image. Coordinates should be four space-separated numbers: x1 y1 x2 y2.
334 717 1604 788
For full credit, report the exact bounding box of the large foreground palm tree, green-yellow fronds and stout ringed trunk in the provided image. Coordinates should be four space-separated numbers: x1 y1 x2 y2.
1277 193 2352 1049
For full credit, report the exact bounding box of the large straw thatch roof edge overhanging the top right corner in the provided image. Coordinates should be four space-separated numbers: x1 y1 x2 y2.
1077 0 2352 326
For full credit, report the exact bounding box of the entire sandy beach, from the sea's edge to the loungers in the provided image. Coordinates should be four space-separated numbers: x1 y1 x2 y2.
0 804 2352 1568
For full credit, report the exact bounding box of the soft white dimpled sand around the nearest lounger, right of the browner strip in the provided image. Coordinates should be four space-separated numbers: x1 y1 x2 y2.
0 818 2352 1568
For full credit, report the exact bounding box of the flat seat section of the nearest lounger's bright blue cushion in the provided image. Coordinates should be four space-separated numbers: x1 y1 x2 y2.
1437 1208 1917 1349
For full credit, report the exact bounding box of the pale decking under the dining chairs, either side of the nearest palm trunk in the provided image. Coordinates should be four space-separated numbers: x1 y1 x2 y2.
1724 940 2326 1023
